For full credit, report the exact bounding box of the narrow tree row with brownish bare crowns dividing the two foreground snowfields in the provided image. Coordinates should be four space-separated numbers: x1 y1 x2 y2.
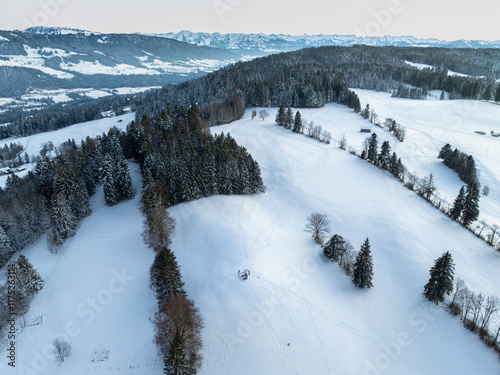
141 172 203 375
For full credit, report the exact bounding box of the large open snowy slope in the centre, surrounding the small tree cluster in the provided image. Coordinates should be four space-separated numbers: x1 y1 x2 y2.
166 105 500 375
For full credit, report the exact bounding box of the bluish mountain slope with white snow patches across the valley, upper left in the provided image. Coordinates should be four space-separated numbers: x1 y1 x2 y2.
0 27 240 98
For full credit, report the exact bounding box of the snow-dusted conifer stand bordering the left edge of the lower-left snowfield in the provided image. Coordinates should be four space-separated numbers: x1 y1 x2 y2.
0 128 136 266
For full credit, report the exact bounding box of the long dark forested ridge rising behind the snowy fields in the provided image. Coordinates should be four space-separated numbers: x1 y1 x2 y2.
0 46 500 137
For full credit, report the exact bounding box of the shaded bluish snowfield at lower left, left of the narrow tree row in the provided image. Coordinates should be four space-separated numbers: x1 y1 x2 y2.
0 164 162 375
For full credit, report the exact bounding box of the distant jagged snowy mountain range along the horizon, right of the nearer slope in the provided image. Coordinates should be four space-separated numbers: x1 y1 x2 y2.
148 30 500 53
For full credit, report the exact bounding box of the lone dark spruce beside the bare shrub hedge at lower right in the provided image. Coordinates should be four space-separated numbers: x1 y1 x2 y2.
424 251 455 303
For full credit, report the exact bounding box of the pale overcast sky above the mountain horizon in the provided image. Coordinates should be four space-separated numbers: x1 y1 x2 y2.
0 0 500 40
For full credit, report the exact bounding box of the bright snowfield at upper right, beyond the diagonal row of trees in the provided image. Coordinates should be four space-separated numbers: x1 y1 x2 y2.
347 89 500 232
